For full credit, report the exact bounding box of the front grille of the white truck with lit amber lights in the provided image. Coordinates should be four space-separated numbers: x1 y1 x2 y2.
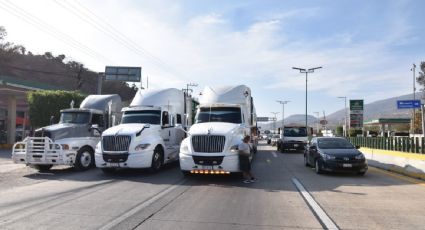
192 135 226 153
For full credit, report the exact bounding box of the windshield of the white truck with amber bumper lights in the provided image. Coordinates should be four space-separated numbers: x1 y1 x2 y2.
195 107 242 124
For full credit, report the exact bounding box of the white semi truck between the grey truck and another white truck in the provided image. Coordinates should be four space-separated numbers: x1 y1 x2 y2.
95 88 192 173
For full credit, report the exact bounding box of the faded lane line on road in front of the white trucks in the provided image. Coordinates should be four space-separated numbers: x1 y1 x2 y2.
99 180 186 230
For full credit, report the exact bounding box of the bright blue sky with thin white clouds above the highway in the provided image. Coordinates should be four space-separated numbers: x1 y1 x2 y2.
0 0 425 121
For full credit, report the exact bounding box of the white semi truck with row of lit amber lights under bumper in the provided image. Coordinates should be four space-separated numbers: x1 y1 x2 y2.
179 85 258 175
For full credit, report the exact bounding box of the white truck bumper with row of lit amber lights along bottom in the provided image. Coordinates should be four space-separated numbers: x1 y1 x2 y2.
179 153 240 174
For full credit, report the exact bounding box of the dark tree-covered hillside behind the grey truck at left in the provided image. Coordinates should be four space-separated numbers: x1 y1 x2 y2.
0 26 137 101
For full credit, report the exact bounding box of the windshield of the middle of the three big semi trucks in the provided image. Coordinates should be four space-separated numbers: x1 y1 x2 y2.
121 110 161 125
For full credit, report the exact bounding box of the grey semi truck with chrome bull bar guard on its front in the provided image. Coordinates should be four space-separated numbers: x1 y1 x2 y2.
12 94 122 171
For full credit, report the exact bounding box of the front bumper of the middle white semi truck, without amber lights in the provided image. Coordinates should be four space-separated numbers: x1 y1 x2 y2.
95 150 153 168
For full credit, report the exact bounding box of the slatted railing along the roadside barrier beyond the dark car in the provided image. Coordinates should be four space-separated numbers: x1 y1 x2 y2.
347 137 425 154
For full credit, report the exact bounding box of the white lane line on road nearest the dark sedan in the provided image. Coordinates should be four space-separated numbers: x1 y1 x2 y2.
292 178 339 230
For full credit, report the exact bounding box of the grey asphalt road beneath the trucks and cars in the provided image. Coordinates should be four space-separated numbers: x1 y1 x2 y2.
0 142 425 230
